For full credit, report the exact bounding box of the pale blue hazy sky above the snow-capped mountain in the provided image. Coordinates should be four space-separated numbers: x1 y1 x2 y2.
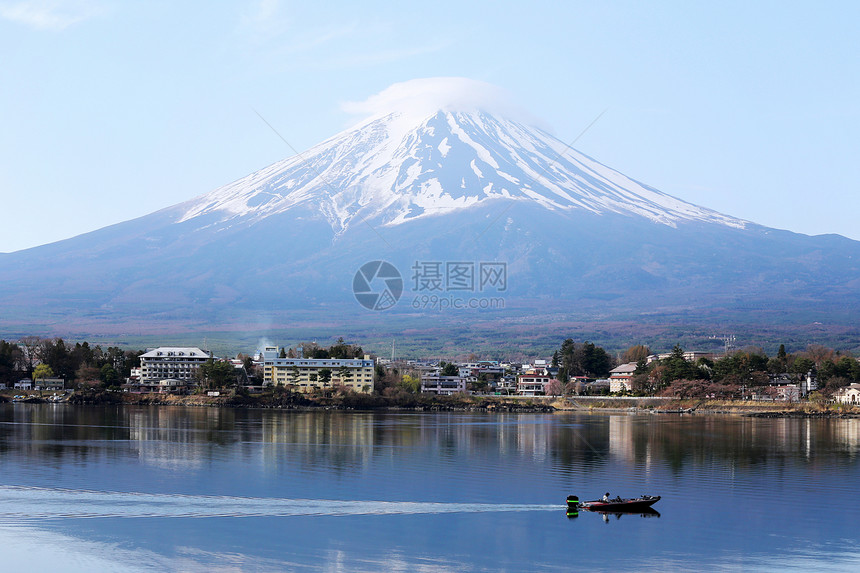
0 0 860 252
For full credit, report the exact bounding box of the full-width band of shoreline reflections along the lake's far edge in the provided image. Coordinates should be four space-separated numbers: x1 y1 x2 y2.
0 404 860 476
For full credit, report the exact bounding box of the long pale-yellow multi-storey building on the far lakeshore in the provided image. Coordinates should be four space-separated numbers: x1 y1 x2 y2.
263 346 374 393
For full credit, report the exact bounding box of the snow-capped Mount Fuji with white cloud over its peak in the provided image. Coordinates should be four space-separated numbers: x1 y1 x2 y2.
0 78 860 329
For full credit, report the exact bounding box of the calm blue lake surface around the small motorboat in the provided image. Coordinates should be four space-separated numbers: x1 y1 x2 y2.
0 404 860 573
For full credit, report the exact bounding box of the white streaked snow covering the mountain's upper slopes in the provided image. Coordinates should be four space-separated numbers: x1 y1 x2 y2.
175 79 747 234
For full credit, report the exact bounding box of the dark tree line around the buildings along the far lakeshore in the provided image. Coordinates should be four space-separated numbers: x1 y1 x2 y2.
0 337 860 413
